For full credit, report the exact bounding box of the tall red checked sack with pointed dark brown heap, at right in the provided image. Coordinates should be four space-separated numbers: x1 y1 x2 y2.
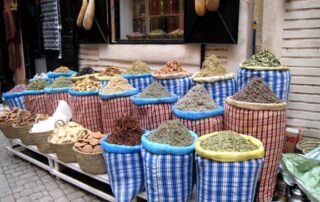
224 78 286 201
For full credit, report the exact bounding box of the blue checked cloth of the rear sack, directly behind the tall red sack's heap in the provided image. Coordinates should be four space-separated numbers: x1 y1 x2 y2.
237 68 291 102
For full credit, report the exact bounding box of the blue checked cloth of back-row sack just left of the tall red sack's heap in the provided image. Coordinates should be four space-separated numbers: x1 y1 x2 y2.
195 78 237 106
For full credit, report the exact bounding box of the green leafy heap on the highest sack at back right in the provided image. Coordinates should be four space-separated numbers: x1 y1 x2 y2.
243 50 281 67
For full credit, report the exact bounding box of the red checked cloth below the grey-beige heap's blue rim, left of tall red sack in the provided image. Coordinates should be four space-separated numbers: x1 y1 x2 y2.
172 114 223 136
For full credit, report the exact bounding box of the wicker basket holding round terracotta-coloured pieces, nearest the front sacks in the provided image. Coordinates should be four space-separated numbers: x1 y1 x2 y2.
73 147 107 175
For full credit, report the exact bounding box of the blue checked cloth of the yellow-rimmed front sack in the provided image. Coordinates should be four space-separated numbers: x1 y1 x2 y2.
195 155 263 202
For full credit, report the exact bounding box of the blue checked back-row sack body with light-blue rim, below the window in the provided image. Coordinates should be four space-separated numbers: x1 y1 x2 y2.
122 73 154 92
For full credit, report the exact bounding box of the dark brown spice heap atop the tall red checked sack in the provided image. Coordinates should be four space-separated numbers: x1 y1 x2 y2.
232 77 280 103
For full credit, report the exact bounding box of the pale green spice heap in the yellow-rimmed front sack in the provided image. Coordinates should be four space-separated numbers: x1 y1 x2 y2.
200 131 258 152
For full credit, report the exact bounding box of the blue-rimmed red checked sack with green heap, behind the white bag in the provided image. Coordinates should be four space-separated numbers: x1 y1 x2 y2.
44 76 72 116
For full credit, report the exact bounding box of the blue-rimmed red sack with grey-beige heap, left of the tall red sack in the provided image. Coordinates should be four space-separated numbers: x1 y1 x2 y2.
172 85 223 136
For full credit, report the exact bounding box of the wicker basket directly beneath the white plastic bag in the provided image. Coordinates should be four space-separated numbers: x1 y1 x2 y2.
29 131 54 154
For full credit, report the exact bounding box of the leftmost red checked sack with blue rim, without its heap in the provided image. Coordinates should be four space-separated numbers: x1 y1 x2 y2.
22 90 48 114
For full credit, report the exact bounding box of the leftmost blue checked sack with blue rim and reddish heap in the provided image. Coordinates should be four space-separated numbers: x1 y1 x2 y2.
2 84 27 109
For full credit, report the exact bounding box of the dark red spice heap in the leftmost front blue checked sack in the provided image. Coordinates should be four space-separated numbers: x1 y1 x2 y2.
107 115 143 146
